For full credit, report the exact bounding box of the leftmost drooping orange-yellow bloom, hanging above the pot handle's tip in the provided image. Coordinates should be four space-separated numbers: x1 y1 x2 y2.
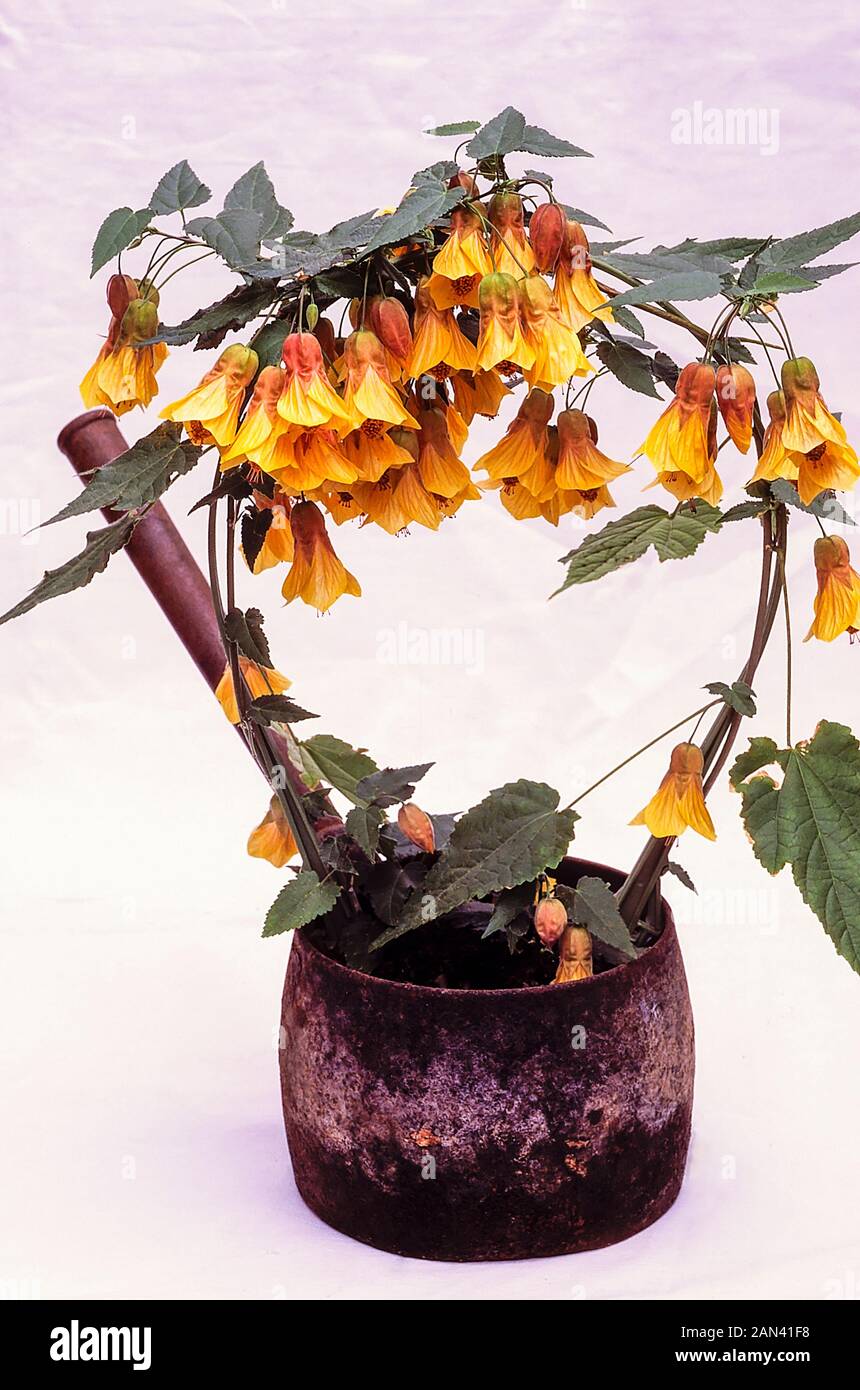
81 275 167 416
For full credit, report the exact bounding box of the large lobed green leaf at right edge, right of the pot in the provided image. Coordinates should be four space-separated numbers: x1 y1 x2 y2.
731 720 860 972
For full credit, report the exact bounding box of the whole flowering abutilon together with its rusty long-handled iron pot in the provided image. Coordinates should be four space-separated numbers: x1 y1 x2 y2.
4 108 860 1259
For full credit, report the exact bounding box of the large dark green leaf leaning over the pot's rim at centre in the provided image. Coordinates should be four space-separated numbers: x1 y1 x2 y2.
377 778 578 945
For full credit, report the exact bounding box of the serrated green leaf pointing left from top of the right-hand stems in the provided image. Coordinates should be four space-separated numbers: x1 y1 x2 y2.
553 502 722 598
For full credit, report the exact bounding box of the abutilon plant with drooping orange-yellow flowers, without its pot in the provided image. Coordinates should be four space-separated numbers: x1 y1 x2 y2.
10 108 860 987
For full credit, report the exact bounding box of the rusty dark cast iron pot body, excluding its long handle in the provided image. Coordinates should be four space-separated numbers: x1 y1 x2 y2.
281 859 695 1261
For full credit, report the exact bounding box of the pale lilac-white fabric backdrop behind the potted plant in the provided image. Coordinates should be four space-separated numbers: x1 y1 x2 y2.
0 0 860 1298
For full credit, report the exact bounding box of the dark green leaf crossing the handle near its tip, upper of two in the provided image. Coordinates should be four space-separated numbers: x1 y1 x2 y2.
44 421 201 525
